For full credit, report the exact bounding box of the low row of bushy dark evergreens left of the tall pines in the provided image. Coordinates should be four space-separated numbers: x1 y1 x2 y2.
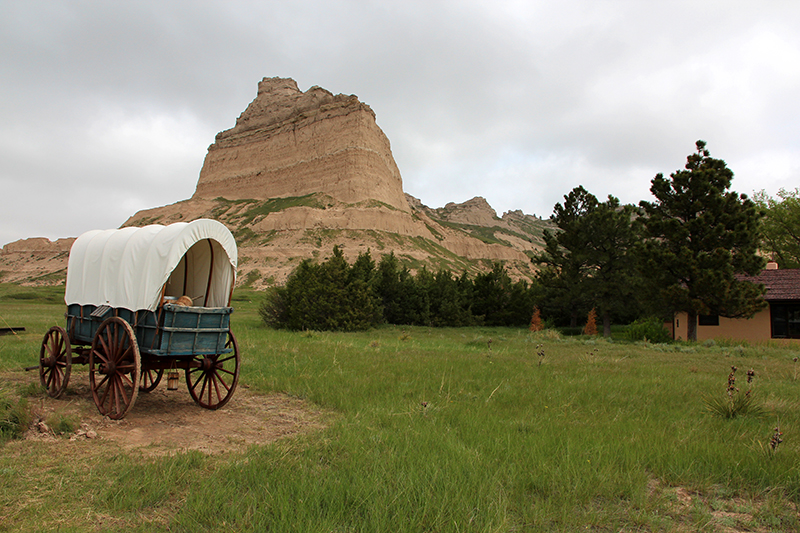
259 246 535 331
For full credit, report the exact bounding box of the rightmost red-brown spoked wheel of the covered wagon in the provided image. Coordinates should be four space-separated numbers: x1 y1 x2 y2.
186 332 239 409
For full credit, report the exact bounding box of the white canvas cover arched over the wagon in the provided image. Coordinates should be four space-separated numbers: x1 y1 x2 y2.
64 219 238 311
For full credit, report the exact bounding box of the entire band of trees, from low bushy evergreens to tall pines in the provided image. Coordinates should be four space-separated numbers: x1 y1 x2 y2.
261 141 800 340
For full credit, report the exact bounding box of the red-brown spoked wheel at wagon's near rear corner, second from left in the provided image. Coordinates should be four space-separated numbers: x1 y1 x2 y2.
89 317 142 420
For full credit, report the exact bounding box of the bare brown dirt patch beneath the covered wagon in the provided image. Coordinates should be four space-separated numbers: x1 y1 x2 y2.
10 372 332 455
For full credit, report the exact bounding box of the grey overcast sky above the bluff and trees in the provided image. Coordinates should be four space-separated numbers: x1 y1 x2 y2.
0 0 800 245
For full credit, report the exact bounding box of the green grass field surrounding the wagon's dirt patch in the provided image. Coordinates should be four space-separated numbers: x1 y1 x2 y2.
0 285 800 532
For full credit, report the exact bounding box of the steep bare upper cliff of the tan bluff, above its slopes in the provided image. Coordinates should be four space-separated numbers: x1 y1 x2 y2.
193 78 409 211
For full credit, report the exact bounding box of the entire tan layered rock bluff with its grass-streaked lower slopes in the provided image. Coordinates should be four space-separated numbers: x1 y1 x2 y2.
0 78 548 287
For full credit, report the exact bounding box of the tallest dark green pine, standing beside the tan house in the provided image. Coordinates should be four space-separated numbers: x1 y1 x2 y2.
640 141 764 340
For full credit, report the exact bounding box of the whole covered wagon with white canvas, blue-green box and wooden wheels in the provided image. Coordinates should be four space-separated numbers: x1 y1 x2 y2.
39 220 240 419
